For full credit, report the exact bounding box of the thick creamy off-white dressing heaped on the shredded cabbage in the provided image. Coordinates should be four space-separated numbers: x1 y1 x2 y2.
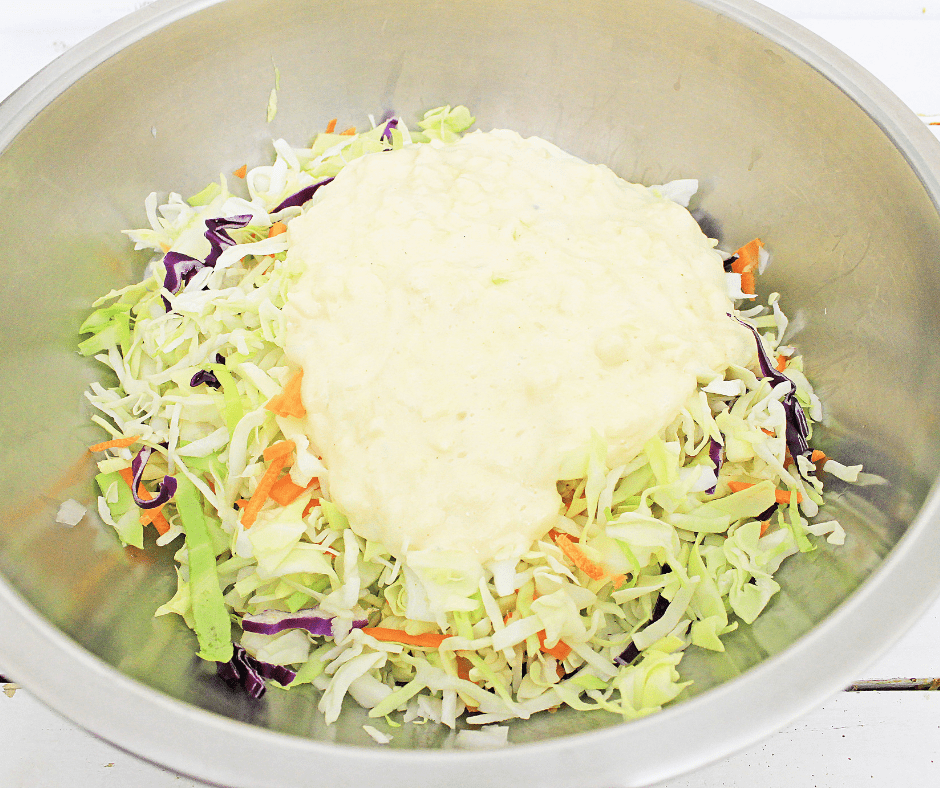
287 131 753 562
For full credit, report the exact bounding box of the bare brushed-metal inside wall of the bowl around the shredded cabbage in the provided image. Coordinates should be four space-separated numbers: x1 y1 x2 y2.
0 0 940 780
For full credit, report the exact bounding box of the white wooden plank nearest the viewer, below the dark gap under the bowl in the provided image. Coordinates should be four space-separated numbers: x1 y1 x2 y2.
0 690 940 788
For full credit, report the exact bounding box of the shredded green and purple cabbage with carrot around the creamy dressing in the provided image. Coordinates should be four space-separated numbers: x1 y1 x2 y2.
79 107 860 741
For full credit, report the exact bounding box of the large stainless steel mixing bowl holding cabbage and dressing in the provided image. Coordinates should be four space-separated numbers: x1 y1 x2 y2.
0 0 940 788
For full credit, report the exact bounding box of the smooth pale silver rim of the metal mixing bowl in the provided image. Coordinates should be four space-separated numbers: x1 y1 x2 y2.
0 0 940 785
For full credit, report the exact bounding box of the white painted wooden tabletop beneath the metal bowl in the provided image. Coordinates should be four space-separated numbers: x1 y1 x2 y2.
0 0 940 788
